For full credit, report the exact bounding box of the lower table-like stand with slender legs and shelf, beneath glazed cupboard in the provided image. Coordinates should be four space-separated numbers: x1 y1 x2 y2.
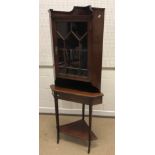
51 85 103 153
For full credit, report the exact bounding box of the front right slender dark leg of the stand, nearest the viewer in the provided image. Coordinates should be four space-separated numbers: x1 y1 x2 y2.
88 104 92 153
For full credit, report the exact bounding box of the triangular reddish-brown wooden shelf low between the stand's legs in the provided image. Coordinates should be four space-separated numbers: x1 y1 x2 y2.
60 120 97 140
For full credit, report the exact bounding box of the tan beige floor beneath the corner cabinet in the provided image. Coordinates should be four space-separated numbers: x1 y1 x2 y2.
39 115 115 155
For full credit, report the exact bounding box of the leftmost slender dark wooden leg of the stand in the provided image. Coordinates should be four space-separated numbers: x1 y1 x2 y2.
54 95 60 144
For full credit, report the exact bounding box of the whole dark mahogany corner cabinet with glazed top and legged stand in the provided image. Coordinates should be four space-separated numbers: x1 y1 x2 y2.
49 6 105 153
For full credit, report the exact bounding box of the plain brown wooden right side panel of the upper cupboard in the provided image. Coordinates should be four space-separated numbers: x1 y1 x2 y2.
91 9 104 90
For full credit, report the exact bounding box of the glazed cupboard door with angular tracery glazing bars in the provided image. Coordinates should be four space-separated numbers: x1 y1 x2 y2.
53 20 88 81
